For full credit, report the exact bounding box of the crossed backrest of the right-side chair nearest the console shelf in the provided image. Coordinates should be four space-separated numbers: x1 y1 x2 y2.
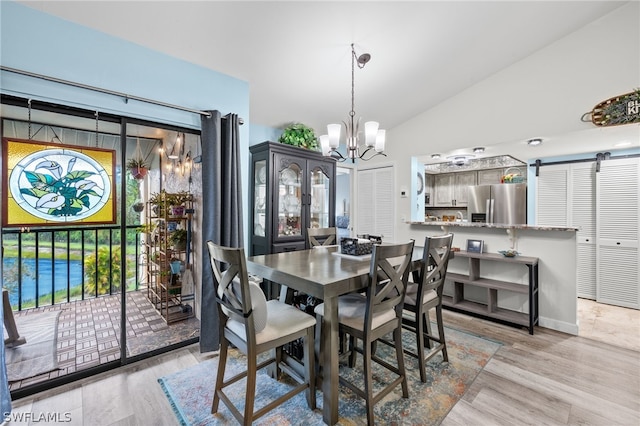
418 234 453 299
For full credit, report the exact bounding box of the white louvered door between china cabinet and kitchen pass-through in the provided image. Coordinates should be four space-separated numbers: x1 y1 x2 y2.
356 167 395 242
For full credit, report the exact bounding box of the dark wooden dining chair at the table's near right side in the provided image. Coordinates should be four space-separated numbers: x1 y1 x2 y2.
315 241 413 425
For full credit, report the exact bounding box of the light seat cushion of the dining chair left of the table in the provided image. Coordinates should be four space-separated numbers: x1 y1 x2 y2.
227 300 316 344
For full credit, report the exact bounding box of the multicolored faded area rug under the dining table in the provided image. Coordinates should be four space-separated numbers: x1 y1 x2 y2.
158 328 501 426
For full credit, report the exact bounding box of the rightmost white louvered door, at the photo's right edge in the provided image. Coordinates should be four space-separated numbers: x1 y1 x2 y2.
596 158 640 309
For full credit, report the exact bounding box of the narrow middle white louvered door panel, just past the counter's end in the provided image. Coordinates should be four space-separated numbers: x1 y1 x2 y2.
568 162 597 299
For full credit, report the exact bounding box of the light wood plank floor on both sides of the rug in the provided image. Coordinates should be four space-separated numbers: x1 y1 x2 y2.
11 301 640 426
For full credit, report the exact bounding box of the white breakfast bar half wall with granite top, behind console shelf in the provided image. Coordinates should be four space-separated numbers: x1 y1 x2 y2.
410 221 578 335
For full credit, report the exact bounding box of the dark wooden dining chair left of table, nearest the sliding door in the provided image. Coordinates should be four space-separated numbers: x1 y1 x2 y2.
207 241 316 425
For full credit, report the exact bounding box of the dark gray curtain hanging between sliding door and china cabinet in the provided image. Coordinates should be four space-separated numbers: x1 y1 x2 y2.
200 111 244 352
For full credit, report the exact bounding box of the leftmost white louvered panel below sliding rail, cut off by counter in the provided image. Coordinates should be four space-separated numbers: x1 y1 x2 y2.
536 165 569 226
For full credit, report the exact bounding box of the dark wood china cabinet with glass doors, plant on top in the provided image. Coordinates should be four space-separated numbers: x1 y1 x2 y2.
249 142 336 256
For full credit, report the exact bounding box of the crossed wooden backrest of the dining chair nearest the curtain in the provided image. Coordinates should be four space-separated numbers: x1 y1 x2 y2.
207 241 255 336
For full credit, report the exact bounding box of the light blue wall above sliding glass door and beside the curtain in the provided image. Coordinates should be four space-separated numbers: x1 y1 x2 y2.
0 0 251 241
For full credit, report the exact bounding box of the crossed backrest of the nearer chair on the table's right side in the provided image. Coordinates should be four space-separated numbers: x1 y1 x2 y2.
365 241 414 327
